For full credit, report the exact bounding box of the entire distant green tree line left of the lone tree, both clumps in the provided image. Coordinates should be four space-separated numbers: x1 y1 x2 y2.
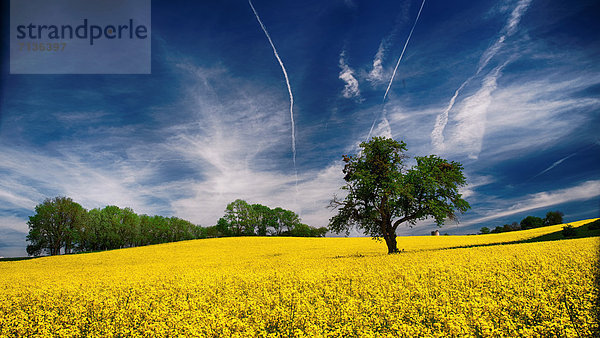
27 196 327 256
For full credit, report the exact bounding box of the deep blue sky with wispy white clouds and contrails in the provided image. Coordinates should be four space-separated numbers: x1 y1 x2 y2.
0 0 600 256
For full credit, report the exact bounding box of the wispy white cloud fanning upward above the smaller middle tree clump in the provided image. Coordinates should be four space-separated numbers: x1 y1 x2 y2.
165 65 341 225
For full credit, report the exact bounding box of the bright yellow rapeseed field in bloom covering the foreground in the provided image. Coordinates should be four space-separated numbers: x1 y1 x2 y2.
0 221 600 337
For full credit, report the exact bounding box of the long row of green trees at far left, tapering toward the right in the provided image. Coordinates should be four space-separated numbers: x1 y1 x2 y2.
27 197 203 256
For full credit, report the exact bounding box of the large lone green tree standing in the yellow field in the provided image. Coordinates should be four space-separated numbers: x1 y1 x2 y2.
329 137 470 254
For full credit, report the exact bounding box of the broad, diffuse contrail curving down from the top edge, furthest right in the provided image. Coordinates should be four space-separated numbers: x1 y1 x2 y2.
431 0 532 150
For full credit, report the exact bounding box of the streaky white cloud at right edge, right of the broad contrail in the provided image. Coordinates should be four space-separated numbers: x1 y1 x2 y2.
476 76 600 160
